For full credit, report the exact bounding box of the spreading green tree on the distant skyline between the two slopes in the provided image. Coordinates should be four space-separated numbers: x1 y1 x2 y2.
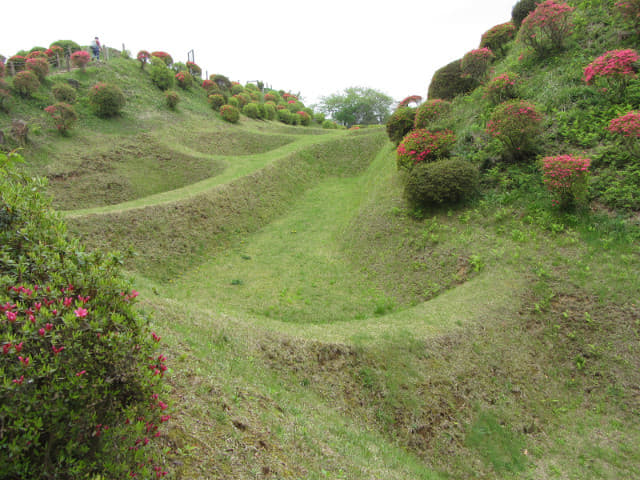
318 87 393 127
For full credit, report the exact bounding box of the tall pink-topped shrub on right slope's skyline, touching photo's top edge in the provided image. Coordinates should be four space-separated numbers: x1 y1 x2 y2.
518 0 575 55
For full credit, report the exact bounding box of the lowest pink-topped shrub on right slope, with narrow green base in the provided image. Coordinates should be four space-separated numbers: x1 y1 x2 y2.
542 155 591 208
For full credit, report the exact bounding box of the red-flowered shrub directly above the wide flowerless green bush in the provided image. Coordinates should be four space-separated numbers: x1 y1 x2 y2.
396 128 456 170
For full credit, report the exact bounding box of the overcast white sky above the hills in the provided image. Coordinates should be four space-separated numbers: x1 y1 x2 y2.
0 0 517 105
